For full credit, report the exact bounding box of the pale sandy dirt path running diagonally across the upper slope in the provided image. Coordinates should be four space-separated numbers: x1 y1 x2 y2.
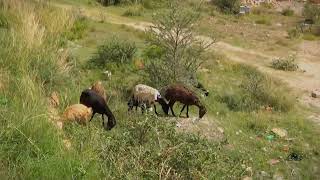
55 1 320 121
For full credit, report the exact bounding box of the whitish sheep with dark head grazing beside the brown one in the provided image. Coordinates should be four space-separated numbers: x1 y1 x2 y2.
128 84 169 115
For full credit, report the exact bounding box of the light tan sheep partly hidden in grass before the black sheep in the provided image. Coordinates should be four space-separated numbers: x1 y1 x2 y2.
62 104 92 125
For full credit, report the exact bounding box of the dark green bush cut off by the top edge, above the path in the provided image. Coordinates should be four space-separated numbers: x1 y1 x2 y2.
212 0 240 14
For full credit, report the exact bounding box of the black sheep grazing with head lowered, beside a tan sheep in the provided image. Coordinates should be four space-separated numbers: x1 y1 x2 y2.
80 89 116 130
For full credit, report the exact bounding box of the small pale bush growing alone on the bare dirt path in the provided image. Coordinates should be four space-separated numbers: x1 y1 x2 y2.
271 55 299 71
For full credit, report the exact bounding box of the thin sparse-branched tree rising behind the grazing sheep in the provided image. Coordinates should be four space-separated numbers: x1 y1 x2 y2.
144 3 213 87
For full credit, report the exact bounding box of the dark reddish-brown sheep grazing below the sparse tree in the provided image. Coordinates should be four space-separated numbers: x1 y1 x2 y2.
164 84 207 118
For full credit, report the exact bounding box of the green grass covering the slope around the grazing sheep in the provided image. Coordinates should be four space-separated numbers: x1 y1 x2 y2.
0 1 320 179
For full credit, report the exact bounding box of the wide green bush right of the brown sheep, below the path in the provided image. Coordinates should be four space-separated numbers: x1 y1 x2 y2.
217 65 294 111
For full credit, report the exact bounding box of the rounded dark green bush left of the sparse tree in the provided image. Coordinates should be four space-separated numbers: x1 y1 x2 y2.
90 37 137 66
